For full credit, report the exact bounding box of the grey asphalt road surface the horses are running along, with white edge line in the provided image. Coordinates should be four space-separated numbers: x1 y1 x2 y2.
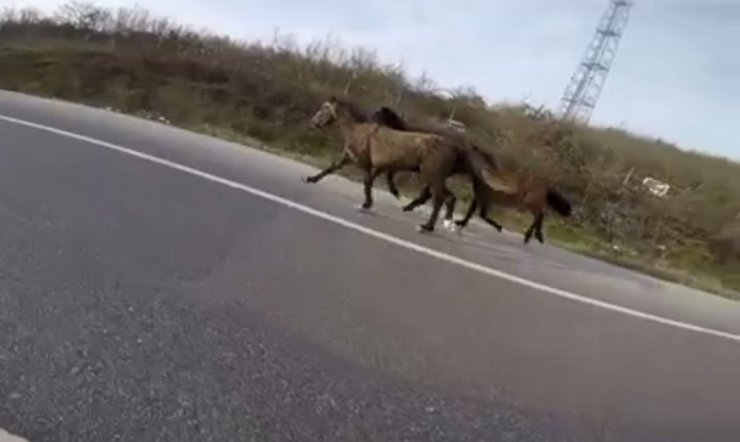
0 92 740 442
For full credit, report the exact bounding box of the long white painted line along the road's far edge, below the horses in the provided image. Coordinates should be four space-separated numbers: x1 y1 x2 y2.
0 111 740 343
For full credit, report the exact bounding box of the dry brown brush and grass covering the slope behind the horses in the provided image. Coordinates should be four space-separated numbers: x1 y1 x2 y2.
0 2 740 297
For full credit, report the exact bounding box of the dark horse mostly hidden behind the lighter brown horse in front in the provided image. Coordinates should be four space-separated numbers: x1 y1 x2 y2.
370 106 503 232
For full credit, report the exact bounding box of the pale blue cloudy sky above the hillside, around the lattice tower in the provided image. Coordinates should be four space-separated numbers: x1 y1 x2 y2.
10 0 740 159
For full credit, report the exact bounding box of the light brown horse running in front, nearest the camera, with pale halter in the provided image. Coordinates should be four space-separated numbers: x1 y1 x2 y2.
305 97 459 232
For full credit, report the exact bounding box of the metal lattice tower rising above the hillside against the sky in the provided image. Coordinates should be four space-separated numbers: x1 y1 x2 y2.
560 0 632 124
